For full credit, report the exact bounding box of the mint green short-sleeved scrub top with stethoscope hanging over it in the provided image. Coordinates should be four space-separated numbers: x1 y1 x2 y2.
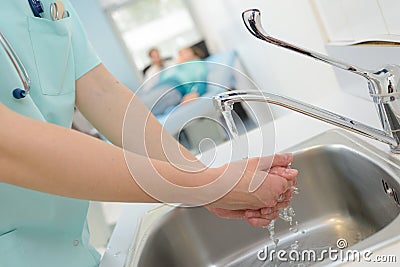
0 0 100 267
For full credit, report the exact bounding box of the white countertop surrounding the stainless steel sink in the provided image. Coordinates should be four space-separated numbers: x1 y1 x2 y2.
100 92 400 267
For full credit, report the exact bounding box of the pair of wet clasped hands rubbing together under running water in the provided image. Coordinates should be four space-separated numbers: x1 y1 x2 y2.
207 154 298 226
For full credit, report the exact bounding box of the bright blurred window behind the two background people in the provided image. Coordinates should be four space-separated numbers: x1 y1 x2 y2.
100 0 202 70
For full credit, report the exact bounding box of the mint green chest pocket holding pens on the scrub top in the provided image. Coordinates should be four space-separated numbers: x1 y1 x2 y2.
28 17 75 96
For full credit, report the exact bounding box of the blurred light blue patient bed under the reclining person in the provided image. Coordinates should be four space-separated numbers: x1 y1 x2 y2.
156 50 245 152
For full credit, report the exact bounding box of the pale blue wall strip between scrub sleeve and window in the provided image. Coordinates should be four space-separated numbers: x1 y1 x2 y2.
70 0 139 91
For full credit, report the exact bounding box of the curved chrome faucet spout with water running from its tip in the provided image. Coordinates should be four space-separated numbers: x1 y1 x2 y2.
213 91 400 153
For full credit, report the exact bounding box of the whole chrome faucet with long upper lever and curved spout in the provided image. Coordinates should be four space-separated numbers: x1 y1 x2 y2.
214 9 400 154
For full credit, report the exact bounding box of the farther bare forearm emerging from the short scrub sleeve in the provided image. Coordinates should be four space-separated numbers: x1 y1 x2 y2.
76 65 200 164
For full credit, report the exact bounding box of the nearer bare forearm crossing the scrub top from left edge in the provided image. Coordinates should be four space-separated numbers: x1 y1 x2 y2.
0 104 213 202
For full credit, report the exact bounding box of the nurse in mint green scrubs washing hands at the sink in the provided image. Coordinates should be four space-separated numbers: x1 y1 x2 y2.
0 0 297 267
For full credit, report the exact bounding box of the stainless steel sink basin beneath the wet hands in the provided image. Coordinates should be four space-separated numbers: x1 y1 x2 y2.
127 130 400 267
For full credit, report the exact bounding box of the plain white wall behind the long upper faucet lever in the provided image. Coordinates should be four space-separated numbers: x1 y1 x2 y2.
188 0 339 117
